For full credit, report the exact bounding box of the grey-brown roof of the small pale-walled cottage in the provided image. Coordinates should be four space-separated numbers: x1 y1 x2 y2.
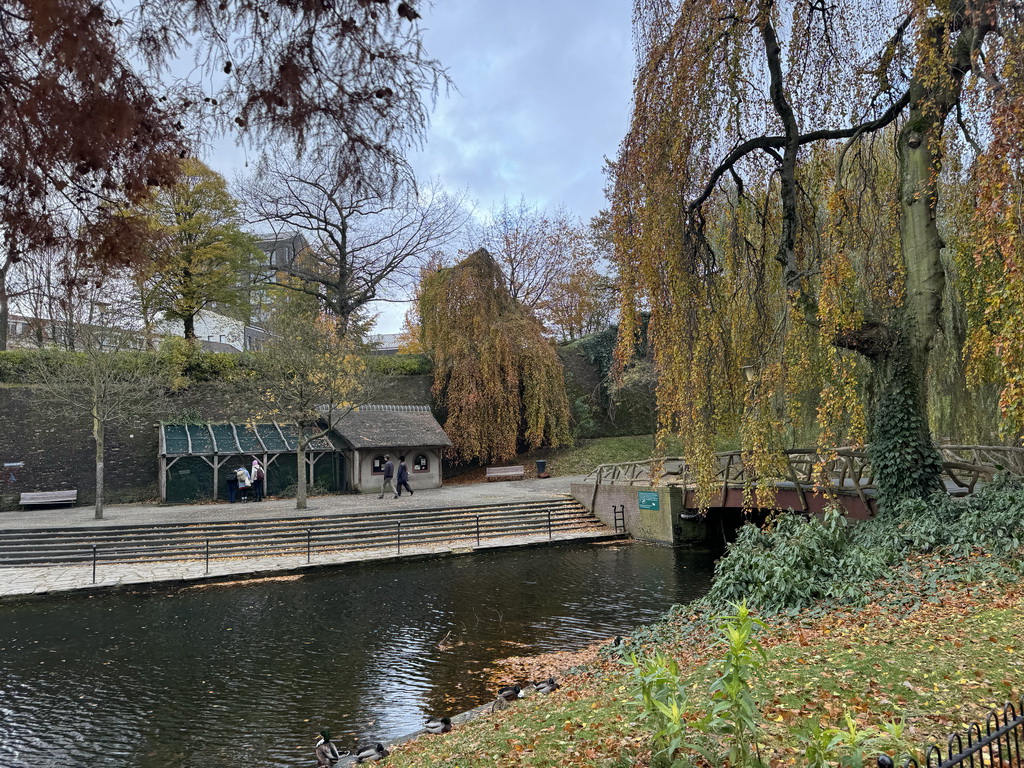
334 406 452 450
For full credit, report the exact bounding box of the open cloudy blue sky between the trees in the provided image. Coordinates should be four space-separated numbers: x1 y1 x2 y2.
203 0 634 333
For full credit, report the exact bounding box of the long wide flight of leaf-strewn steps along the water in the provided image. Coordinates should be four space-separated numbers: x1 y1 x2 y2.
0 499 611 567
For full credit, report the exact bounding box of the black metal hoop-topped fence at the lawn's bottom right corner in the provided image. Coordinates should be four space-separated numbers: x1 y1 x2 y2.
879 698 1024 768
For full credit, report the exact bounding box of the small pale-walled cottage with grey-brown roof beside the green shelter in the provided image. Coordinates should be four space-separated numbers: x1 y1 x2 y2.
334 406 452 494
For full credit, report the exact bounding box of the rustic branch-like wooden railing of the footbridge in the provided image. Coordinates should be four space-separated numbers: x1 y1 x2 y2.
587 445 1024 504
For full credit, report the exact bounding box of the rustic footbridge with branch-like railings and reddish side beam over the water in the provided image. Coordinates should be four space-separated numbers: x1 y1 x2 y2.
586 445 1024 519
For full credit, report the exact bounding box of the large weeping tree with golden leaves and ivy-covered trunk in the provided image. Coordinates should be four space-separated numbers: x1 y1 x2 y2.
612 0 1024 503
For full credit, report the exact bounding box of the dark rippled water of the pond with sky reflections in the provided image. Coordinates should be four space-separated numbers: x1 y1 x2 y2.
0 544 713 768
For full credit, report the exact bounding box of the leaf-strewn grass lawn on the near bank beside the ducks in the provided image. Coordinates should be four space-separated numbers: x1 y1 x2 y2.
380 557 1024 768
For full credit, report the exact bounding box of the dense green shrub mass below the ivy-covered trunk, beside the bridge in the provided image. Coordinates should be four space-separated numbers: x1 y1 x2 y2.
705 478 1024 613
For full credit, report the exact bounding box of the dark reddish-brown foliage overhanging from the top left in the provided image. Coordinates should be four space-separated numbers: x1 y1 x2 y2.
0 0 447 348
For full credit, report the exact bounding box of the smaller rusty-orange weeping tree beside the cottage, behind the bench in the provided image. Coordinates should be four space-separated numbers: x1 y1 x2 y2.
419 249 569 462
